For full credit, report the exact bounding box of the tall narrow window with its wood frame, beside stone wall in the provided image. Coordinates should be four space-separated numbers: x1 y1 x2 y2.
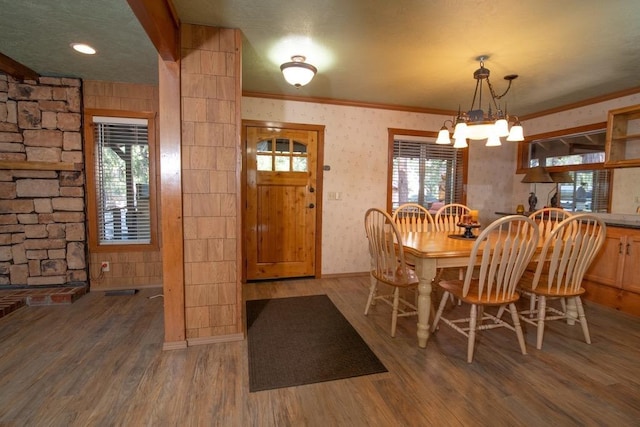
85 114 156 250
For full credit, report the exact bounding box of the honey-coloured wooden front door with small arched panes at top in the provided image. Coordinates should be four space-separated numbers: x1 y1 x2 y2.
244 124 322 280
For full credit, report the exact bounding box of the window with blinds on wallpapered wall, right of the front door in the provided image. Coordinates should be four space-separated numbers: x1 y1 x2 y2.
389 129 466 210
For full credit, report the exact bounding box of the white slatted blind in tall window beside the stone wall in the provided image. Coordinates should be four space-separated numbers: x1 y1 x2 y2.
93 116 151 245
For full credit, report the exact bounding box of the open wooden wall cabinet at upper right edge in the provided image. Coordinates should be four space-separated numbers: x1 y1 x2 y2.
604 105 640 168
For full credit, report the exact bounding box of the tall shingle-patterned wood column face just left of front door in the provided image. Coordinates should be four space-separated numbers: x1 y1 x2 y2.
180 24 244 346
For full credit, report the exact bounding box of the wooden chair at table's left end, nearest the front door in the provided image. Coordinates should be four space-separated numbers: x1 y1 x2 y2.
364 208 418 337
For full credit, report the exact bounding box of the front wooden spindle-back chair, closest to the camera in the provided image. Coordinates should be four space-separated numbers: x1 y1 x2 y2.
431 215 539 363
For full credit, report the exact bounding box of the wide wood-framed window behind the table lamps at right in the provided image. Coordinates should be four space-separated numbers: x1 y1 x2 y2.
520 123 612 212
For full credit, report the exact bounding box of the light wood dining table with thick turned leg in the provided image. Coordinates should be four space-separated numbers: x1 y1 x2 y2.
401 231 475 348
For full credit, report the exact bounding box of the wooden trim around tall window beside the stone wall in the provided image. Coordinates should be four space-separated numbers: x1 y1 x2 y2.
83 109 160 252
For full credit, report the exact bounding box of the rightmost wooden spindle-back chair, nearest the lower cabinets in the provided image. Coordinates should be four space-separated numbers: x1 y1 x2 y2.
519 214 606 349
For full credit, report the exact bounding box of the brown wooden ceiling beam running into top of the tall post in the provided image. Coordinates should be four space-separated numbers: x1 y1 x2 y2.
127 0 180 61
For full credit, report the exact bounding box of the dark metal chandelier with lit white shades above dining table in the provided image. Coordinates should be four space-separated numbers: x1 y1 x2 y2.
436 56 524 148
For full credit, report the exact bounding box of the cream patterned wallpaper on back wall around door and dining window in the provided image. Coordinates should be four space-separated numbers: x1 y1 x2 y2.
242 97 516 274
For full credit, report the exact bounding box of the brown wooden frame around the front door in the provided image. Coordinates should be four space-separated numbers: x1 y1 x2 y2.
238 119 325 283
